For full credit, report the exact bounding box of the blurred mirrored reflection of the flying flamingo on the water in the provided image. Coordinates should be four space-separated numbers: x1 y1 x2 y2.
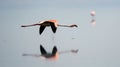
23 45 78 60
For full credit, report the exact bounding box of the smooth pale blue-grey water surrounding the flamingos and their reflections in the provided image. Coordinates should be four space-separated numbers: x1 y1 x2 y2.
0 0 120 67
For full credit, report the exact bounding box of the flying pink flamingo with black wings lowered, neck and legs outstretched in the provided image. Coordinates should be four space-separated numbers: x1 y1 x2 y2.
21 20 78 35
